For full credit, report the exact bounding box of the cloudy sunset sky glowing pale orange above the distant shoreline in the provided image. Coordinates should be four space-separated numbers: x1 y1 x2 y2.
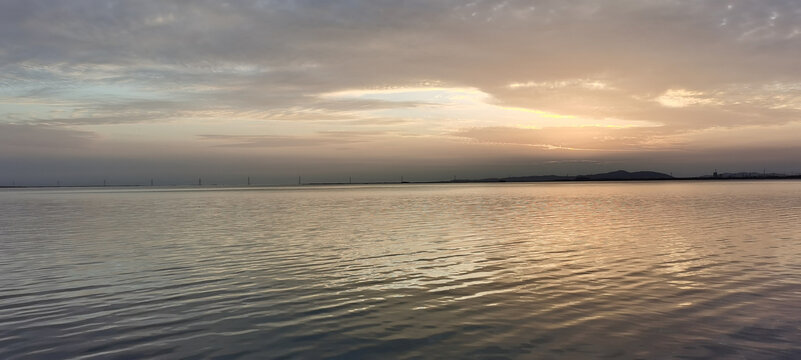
0 0 801 185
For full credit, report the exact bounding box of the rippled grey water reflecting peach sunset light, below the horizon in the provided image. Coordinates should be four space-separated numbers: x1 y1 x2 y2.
0 181 801 359
